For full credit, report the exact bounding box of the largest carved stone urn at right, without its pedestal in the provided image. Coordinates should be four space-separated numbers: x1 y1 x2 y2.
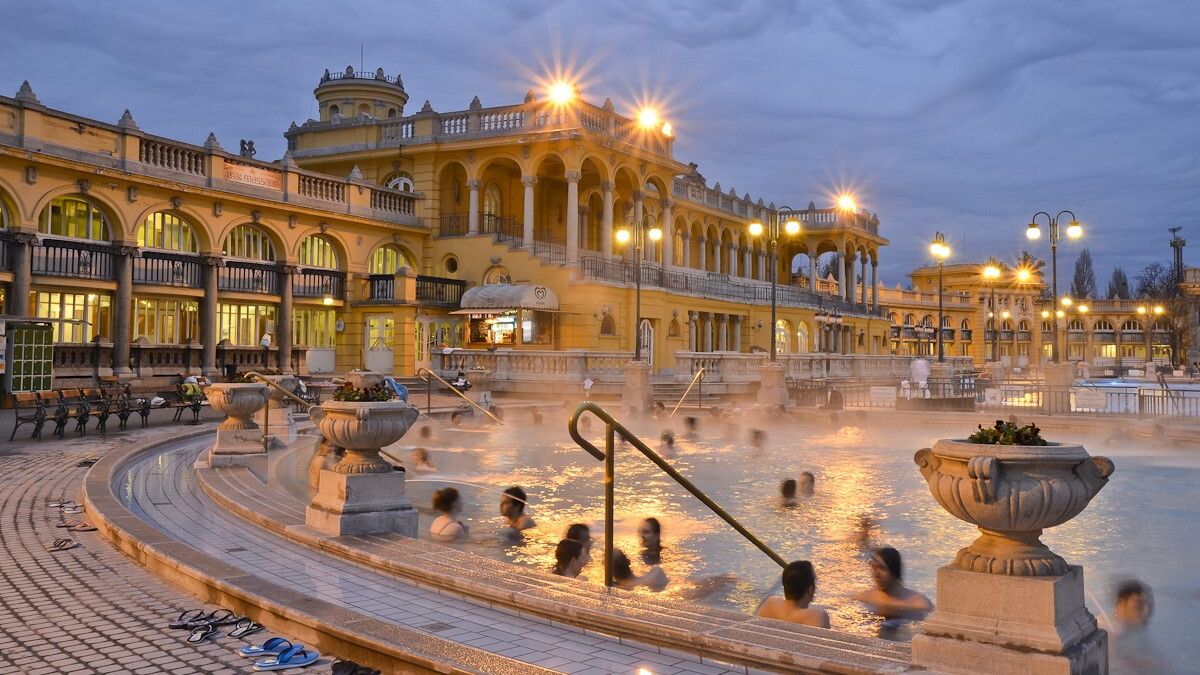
913 440 1114 577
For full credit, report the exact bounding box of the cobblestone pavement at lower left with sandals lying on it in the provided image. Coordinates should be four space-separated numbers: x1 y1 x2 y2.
0 413 330 675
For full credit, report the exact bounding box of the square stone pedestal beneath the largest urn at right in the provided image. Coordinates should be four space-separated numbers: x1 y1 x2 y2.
912 565 1108 675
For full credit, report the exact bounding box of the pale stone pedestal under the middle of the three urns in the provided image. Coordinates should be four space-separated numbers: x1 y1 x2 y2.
305 467 418 538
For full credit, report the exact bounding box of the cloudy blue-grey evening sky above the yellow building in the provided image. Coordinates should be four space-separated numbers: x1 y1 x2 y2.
0 0 1200 284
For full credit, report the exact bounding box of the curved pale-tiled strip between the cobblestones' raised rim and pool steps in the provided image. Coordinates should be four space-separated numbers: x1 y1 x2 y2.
121 440 745 675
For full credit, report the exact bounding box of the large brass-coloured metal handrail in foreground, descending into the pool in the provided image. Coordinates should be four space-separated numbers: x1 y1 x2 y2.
566 401 787 587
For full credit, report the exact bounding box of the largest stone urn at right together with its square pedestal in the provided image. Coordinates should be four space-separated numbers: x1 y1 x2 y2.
912 432 1114 674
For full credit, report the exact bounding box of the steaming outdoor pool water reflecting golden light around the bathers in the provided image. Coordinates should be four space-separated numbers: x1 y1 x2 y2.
278 413 1200 670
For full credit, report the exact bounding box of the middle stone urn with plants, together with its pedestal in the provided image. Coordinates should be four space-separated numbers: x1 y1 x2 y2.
305 401 419 537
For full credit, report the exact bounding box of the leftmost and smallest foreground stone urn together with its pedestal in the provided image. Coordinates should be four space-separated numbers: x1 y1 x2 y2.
204 383 266 478
